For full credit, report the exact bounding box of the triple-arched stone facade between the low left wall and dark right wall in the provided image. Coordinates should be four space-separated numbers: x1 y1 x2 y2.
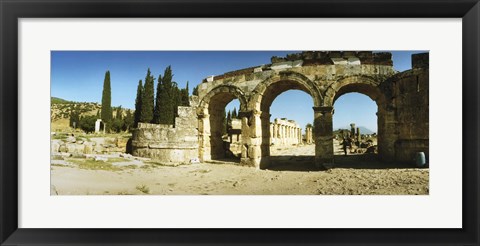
197 52 428 168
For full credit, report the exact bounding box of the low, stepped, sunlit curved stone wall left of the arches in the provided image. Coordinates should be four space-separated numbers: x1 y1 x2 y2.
132 96 199 163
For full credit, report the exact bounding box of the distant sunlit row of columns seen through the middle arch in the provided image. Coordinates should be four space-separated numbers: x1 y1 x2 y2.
270 118 302 146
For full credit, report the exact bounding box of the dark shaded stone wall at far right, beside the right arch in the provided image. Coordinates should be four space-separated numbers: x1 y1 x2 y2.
393 53 429 162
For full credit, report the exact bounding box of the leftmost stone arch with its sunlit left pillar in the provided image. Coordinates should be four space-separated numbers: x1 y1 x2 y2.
197 85 247 161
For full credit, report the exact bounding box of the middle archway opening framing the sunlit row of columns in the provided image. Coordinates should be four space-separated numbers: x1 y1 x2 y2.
260 80 315 171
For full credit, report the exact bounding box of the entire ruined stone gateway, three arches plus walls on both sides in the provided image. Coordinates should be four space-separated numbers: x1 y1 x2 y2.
132 51 429 168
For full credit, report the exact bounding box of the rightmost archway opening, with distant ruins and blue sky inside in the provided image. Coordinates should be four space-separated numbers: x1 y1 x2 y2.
333 91 379 168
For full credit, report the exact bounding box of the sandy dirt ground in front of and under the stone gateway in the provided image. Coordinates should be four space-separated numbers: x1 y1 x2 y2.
51 140 429 195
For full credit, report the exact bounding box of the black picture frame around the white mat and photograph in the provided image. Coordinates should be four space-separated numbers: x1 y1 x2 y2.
0 0 480 245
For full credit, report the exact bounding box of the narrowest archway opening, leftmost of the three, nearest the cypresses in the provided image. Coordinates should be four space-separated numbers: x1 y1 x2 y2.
208 92 242 162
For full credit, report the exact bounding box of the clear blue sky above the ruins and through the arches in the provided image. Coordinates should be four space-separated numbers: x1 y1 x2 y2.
51 51 426 134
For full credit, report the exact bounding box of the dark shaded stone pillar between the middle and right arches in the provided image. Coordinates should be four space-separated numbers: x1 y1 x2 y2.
313 106 333 168
